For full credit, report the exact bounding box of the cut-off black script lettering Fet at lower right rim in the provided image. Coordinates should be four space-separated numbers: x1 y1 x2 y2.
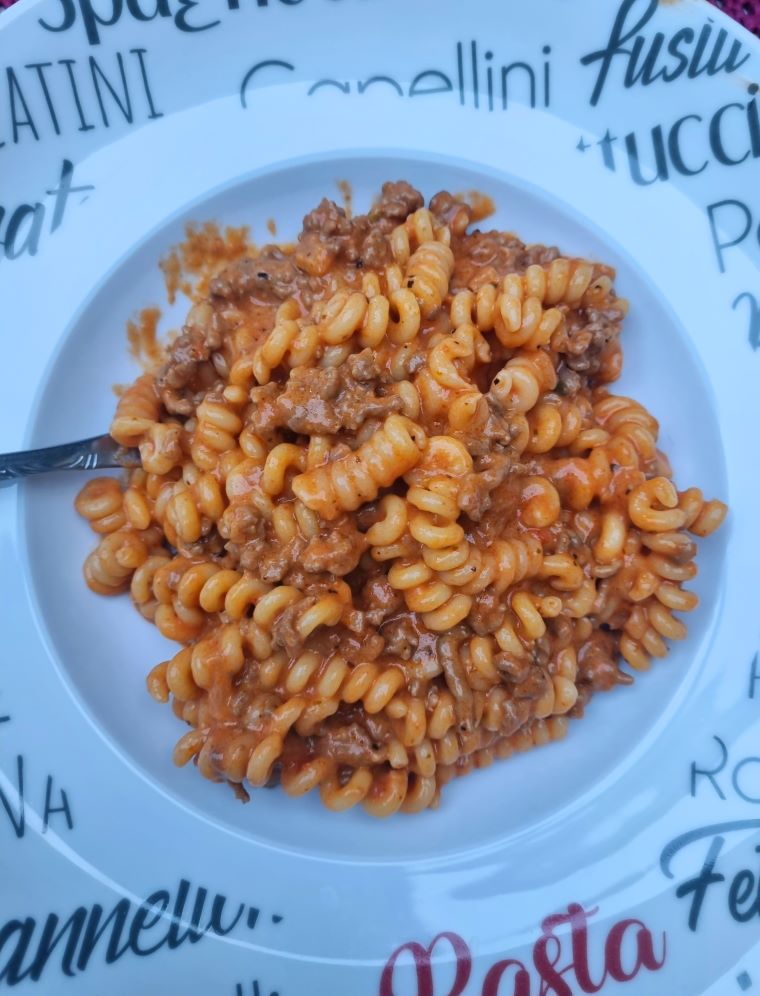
660 820 760 931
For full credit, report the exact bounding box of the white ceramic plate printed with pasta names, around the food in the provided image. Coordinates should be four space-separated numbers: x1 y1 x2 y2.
0 0 760 996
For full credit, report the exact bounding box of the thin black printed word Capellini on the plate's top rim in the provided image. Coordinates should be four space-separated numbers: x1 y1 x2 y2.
240 41 552 111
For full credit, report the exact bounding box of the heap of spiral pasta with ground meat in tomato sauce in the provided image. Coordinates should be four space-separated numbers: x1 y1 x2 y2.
75 182 727 817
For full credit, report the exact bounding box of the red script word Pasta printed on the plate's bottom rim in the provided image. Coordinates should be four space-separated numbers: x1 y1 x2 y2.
379 903 667 996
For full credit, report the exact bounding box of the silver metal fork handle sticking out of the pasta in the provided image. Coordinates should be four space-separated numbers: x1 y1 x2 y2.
0 435 140 488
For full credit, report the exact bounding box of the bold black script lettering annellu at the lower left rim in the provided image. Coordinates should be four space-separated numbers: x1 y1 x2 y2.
0 879 259 986
